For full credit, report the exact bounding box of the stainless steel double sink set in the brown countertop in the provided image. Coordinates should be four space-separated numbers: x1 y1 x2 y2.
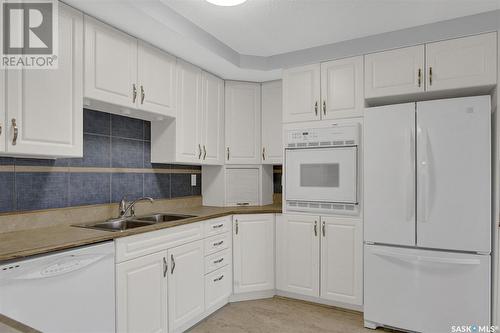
74 214 195 231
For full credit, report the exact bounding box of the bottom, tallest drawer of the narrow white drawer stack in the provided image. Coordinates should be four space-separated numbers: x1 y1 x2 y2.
205 266 233 311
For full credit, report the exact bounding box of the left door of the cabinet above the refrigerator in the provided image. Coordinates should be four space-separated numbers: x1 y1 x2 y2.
365 45 425 98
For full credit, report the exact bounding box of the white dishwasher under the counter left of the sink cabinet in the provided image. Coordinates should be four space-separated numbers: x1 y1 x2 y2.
0 242 115 333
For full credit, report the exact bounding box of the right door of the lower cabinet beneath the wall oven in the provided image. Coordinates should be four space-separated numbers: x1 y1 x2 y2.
320 216 363 305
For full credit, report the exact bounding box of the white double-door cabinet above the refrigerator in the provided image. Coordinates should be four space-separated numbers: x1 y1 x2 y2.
365 32 497 99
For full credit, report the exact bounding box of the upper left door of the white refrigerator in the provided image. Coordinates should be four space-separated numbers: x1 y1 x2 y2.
363 103 416 246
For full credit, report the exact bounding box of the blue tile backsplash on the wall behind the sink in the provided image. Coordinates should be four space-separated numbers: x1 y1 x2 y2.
0 109 201 213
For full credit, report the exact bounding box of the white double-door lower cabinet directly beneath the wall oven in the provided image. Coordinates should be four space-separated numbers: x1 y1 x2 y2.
276 214 363 305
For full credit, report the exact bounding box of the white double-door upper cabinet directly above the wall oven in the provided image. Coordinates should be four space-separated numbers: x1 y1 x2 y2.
283 57 364 122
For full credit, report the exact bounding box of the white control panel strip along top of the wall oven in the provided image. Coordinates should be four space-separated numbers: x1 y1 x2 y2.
286 124 359 148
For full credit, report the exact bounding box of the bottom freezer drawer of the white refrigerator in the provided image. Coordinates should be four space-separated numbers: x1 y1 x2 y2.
364 245 491 333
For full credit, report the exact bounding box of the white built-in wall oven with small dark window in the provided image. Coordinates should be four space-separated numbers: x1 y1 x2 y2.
284 124 360 215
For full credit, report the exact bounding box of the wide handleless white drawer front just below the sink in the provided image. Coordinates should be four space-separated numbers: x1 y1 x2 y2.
115 222 203 263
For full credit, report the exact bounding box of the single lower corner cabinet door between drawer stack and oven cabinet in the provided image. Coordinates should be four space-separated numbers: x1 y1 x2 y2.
233 214 274 294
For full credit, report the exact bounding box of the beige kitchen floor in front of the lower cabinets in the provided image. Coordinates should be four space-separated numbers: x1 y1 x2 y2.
189 297 394 333
